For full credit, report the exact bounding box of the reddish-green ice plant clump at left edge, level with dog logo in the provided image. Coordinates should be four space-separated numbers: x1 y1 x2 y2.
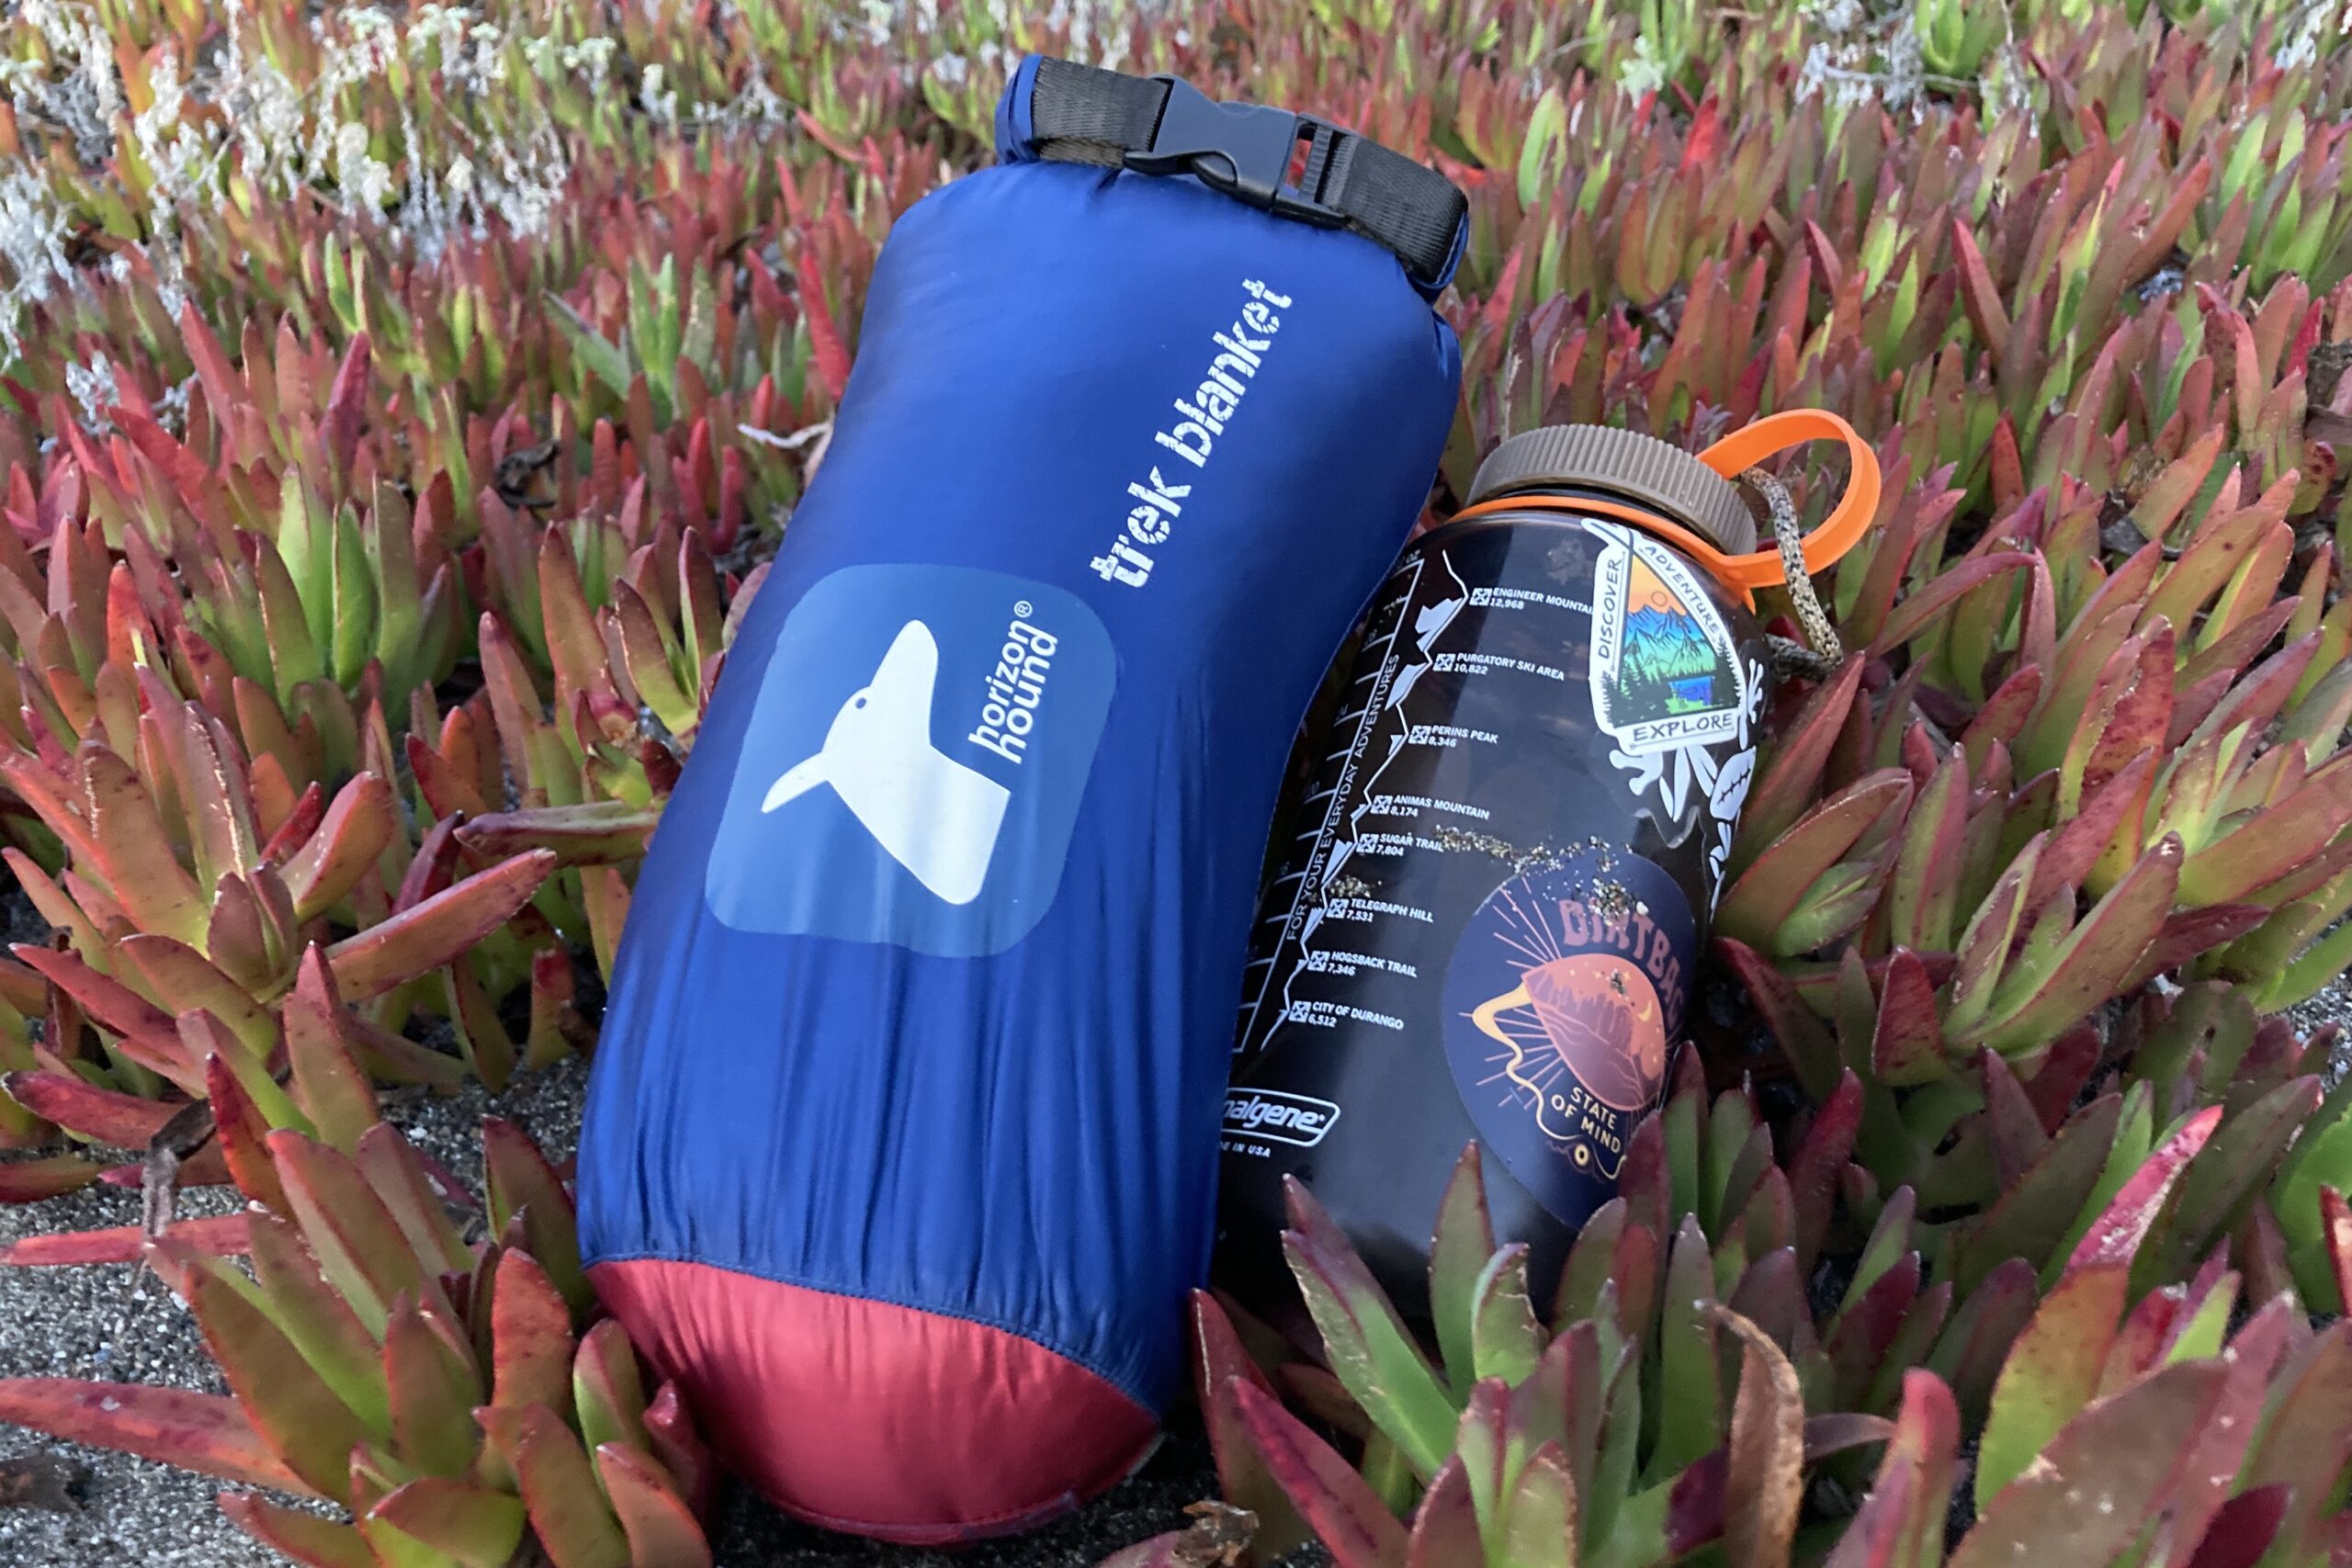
0 696 555 1170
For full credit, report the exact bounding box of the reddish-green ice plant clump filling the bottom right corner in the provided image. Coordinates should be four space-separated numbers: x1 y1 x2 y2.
1830 1175 2352 1568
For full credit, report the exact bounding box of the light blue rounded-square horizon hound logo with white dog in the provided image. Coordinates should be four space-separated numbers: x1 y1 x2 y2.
703 564 1114 957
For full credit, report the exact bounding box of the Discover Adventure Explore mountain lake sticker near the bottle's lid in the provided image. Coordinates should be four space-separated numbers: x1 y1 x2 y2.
1585 522 1747 757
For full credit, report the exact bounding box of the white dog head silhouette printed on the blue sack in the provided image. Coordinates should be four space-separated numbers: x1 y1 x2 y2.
760 621 1012 905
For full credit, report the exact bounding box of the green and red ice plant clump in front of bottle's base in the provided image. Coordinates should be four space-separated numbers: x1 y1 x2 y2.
1166 1149 1884 1563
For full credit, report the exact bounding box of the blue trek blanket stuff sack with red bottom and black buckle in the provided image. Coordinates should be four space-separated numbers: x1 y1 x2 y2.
579 59 1463 1542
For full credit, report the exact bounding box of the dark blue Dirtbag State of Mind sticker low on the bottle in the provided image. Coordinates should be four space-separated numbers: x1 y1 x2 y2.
1444 851 1698 1224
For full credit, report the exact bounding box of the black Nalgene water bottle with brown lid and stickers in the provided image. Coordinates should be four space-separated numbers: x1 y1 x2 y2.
1218 416 1844 1316
